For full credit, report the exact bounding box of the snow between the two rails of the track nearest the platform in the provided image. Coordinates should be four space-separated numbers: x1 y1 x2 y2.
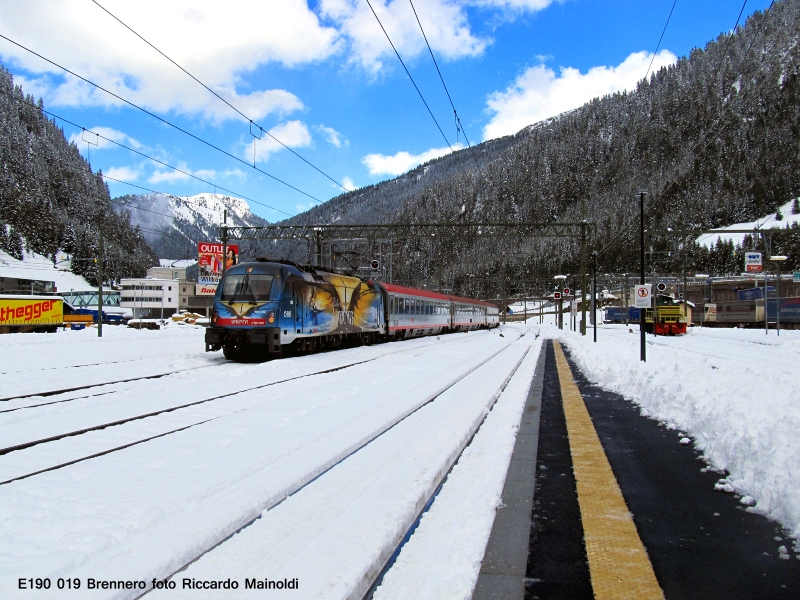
146 328 535 600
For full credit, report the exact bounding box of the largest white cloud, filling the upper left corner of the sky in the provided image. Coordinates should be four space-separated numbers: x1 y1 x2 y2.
0 0 334 121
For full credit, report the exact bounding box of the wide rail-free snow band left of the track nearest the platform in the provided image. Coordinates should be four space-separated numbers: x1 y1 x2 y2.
0 333 519 598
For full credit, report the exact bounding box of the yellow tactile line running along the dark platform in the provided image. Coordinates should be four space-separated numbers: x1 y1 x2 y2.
553 341 664 600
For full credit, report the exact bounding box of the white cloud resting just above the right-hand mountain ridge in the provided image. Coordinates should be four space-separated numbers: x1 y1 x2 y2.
483 50 677 140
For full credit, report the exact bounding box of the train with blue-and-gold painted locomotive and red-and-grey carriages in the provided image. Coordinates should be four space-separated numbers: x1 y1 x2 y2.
205 260 499 359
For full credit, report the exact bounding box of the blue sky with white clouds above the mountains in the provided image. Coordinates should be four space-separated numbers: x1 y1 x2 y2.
0 0 769 221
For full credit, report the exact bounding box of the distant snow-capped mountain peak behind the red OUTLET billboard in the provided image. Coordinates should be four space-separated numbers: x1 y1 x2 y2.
114 193 268 259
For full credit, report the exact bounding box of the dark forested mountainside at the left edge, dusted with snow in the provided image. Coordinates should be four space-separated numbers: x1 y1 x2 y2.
0 66 156 284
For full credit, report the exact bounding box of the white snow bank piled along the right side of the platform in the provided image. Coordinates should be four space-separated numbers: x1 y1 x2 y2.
546 325 800 537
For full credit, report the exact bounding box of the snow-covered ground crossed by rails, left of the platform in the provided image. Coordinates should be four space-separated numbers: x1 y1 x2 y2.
0 325 541 598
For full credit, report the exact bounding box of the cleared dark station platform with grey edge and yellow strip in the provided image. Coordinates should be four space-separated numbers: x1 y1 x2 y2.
473 340 800 600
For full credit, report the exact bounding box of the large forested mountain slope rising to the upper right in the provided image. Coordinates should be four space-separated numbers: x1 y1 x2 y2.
290 0 800 297
